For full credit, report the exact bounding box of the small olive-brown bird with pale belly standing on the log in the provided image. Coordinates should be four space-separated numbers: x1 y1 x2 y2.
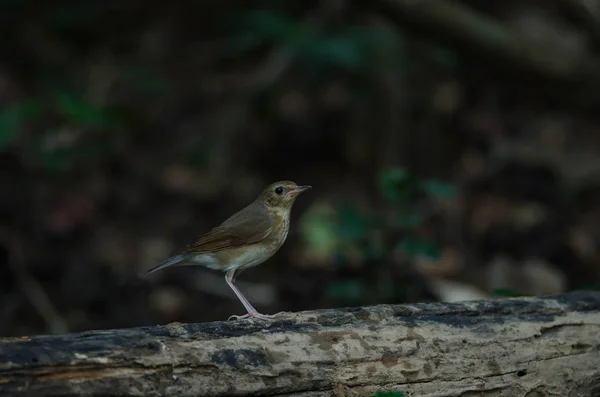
146 181 311 319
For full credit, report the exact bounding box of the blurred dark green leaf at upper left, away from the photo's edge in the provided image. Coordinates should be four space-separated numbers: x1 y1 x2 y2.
54 92 116 128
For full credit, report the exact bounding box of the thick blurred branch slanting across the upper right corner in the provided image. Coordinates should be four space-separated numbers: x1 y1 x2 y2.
368 0 600 109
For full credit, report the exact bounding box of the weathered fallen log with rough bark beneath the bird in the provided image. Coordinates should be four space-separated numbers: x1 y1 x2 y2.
0 292 600 397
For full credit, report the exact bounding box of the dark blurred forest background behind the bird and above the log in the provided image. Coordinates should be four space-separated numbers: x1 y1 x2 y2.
0 0 600 336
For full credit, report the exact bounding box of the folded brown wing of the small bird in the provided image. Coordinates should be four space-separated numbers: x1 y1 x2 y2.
182 206 271 254
